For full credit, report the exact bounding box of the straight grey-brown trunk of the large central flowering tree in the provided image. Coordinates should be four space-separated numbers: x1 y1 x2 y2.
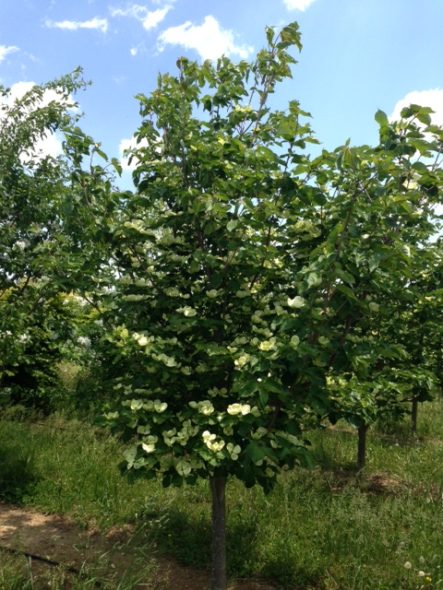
210 475 227 590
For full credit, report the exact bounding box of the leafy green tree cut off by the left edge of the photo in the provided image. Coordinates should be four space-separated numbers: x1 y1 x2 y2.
0 71 118 411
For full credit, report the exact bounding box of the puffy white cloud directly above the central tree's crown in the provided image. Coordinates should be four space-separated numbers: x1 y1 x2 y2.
158 16 253 59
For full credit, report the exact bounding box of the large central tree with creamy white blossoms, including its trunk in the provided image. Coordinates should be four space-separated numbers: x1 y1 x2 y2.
104 24 330 590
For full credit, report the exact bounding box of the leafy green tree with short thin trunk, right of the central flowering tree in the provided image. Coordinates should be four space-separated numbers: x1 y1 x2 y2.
311 106 442 467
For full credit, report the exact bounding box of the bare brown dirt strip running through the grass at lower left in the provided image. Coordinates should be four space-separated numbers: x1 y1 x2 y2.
0 503 273 590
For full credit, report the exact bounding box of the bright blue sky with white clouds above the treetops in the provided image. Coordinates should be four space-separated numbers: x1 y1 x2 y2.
0 0 443 176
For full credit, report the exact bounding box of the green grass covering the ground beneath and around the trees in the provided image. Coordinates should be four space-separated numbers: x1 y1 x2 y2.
0 400 443 590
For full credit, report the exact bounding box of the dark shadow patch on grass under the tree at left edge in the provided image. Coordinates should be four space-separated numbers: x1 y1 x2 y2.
0 439 38 504
